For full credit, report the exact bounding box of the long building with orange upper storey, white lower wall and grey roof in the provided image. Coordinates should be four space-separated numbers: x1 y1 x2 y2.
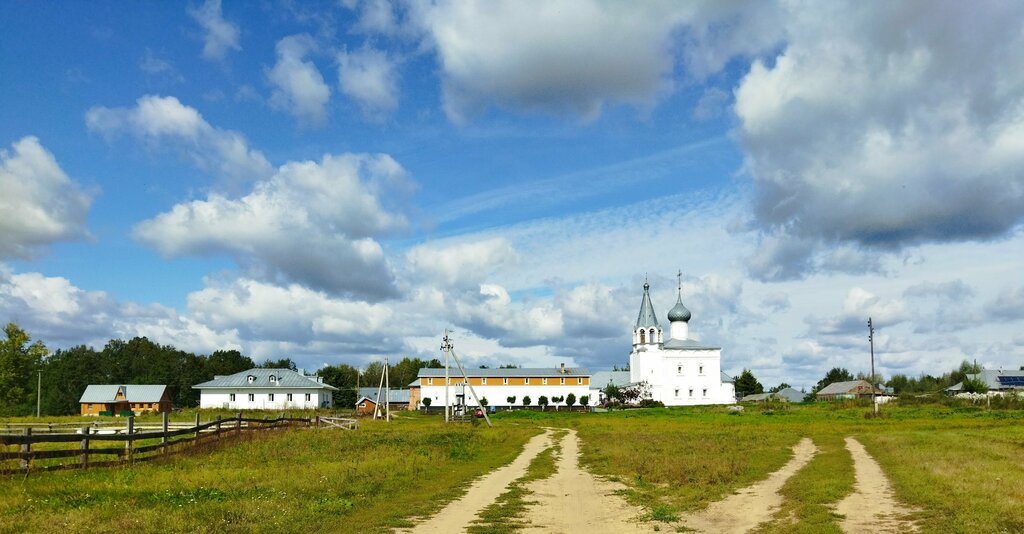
418 365 597 408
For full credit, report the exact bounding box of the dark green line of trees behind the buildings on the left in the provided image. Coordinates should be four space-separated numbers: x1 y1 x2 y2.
0 323 442 416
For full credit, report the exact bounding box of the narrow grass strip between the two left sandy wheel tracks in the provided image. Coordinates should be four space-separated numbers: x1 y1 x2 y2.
467 430 567 534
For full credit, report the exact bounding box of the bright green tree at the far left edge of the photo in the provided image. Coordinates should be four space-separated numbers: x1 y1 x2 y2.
0 323 49 415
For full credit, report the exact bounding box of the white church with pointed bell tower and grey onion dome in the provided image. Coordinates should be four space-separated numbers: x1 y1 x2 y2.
630 274 736 406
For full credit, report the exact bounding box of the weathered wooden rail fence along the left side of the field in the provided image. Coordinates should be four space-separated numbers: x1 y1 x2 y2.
0 412 357 475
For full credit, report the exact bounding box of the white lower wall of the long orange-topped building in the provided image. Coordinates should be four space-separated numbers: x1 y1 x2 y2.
420 383 594 408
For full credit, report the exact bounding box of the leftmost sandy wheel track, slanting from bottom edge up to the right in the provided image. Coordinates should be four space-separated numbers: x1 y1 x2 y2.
397 429 551 534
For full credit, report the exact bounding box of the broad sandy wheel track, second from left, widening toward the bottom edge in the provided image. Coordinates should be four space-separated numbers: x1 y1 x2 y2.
523 429 653 534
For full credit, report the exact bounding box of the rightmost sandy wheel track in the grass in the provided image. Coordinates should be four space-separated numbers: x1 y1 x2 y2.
836 438 918 533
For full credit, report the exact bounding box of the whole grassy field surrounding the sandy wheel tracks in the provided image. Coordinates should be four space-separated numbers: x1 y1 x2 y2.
0 405 1024 532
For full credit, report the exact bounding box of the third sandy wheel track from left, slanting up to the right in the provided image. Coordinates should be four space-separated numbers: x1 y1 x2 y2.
680 438 818 533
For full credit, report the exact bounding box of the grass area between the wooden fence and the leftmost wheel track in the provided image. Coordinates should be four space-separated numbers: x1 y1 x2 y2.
0 417 539 533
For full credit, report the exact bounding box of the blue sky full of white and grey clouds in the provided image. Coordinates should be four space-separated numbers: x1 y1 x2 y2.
0 0 1024 386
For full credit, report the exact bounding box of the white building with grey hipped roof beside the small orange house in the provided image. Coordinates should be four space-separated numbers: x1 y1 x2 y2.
193 368 338 410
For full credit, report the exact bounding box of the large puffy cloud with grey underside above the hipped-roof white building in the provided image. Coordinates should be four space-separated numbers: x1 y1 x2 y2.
134 154 407 298
